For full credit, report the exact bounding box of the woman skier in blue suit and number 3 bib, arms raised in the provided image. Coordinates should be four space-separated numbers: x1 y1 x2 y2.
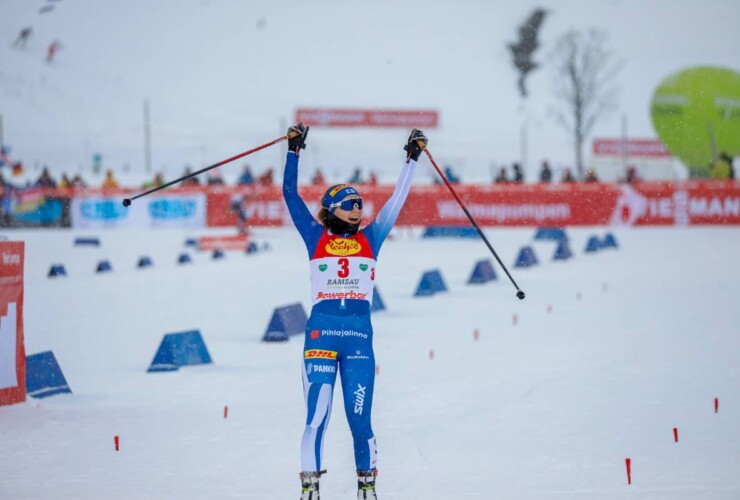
283 124 428 500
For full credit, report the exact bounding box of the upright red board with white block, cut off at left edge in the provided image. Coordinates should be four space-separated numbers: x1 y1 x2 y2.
0 241 26 406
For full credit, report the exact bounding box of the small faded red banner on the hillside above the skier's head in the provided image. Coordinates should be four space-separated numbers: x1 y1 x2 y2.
295 108 439 128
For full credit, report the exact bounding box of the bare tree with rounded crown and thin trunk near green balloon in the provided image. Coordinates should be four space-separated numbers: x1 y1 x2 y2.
551 29 621 179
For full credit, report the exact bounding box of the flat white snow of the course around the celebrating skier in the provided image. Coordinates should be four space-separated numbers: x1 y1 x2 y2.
0 227 740 500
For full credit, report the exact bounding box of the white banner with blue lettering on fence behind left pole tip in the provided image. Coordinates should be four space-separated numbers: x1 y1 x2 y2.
70 193 206 229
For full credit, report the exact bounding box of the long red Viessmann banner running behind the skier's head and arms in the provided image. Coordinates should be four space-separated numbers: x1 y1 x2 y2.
206 181 740 227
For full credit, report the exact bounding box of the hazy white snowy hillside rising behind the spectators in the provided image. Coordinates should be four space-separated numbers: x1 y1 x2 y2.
0 0 740 178
